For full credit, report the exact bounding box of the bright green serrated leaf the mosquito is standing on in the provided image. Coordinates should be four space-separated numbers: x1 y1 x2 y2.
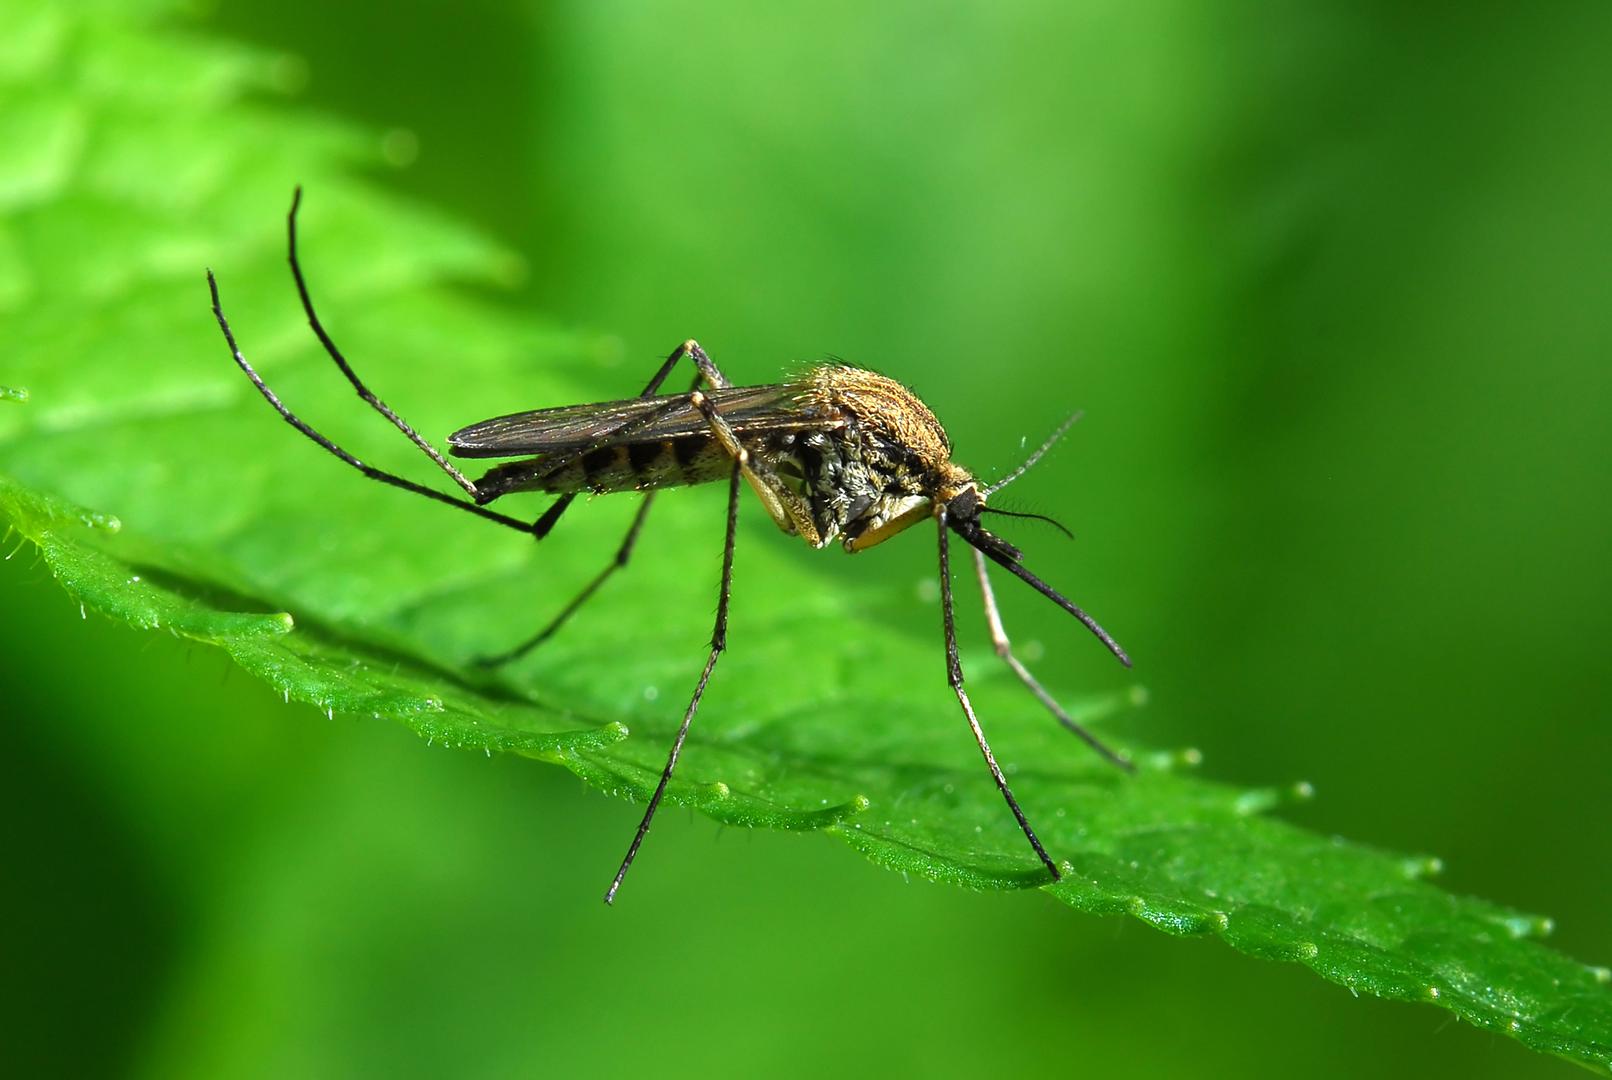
0 3 1612 1070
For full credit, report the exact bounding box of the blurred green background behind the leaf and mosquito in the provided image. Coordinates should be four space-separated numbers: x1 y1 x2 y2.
0 0 1612 1077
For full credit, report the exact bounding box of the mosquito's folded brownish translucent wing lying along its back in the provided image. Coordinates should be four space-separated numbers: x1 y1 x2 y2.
448 382 838 458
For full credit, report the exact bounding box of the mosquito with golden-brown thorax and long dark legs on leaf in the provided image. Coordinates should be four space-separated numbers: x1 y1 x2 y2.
206 187 1132 904
